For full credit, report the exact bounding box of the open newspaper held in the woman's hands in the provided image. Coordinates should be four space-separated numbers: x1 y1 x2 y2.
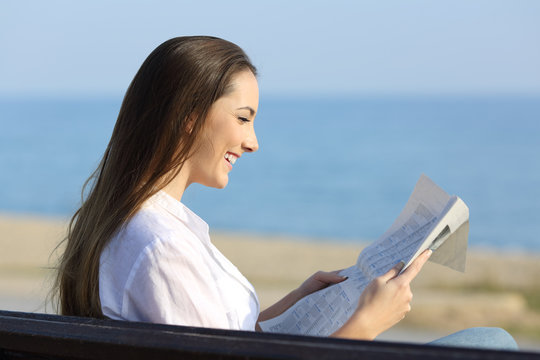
259 175 469 336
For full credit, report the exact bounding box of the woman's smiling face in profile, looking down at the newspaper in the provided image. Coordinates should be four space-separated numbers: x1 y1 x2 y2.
188 70 259 189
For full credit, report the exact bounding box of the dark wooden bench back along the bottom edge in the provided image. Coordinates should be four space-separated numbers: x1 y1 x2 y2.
0 311 540 360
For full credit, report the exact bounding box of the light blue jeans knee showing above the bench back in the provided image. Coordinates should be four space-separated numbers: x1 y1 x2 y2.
427 327 518 350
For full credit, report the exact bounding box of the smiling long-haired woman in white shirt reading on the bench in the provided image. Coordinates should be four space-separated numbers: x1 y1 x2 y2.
57 37 520 346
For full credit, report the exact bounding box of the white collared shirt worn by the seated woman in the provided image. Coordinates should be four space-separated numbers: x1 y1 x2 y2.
99 191 259 330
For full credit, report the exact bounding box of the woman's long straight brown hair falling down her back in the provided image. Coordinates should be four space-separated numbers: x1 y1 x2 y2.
53 36 256 317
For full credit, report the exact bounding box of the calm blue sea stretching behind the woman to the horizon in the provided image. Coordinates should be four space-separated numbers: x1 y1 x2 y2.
0 95 540 252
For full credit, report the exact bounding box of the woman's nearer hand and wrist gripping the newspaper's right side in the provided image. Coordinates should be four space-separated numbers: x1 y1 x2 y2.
333 250 432 340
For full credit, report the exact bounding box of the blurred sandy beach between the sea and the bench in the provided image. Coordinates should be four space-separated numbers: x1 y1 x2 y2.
0 213 540 350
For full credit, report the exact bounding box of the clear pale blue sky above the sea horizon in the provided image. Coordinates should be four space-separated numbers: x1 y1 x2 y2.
0 0 540 96
